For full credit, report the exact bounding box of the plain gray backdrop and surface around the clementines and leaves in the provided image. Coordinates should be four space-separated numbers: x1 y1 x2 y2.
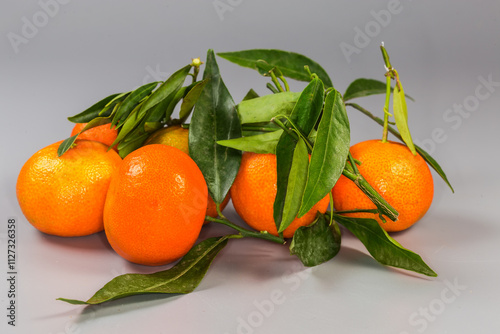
0 0 500 333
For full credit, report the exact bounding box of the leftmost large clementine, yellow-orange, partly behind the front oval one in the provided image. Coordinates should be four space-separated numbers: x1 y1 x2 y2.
16 139 121 237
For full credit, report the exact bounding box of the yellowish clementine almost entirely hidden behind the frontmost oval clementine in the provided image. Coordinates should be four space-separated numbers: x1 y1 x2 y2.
144 125 229 223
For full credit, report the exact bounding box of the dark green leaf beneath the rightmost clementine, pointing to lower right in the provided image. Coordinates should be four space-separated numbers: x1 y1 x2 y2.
332 213 437 277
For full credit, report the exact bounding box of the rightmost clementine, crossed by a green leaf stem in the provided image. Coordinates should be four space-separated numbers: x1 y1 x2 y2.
332 140 434 232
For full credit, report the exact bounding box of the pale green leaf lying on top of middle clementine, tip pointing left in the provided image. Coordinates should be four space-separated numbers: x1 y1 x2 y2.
217 129 283 154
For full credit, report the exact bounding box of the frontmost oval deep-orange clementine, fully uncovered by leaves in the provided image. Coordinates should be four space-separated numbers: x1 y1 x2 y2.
104 144 208 266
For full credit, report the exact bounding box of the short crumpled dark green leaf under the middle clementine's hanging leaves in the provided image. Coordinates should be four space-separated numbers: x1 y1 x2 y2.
290 213 341 267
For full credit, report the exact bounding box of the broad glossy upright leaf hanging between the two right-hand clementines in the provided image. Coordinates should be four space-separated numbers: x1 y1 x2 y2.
298 90 351 217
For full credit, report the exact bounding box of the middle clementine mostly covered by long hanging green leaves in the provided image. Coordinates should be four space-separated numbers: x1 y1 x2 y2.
231 152 329 238
